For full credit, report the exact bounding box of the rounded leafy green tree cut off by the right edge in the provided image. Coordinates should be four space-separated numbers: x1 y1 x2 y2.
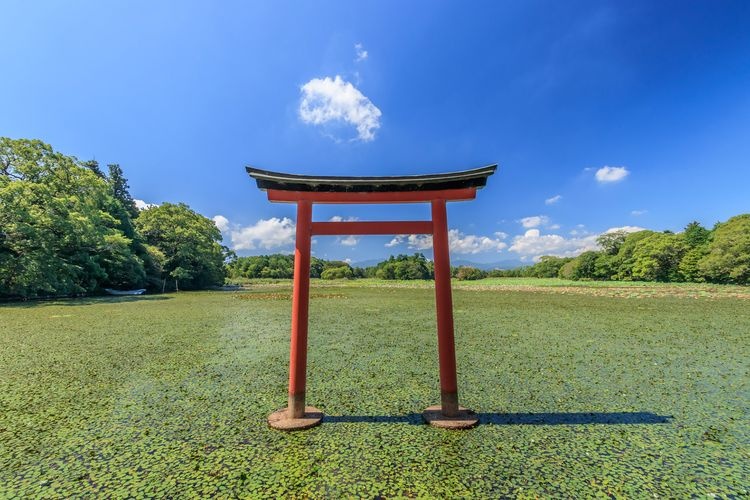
698 214 750 285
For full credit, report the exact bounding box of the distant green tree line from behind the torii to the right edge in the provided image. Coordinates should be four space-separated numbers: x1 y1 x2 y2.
227 223 750 285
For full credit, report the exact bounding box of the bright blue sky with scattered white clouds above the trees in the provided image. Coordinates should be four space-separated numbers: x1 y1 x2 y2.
0 1 750 262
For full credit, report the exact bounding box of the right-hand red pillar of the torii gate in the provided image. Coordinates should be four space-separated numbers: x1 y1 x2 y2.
432 200 458 417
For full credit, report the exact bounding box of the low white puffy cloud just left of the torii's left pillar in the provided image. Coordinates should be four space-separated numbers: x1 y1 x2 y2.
214 215 296 250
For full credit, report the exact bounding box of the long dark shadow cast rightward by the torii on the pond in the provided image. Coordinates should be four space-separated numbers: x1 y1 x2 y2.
323 411 674 425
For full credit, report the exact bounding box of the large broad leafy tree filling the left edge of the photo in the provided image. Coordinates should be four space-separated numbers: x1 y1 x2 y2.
0 138 144 297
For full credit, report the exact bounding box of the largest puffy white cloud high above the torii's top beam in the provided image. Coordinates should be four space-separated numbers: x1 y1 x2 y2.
299 75 382 142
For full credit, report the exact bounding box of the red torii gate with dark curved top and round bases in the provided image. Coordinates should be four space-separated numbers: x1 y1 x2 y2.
246 165 497 430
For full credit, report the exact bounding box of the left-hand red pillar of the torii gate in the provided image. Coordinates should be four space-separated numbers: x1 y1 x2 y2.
289 201 312 418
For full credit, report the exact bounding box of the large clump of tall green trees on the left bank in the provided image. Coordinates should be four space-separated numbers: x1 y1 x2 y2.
0 137 231 298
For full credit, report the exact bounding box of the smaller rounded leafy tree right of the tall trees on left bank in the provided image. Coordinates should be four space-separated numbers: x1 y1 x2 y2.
135 203 228 289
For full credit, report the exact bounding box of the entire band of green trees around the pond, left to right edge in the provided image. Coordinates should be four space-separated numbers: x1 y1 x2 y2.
0 137 750 298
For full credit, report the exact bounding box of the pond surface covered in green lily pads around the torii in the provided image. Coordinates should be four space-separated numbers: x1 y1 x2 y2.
0 280 750 497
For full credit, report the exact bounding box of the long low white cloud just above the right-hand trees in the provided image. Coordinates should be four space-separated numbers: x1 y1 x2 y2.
508 226 643 260
